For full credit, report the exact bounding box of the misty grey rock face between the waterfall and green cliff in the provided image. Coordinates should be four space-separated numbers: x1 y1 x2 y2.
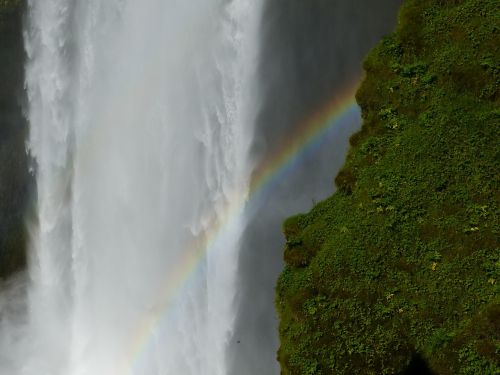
230 0 402 375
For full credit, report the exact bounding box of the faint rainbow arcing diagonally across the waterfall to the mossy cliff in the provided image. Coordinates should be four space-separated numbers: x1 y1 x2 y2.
117 79 359 375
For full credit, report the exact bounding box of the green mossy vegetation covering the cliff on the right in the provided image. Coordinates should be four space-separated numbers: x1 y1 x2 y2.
276 0 500 375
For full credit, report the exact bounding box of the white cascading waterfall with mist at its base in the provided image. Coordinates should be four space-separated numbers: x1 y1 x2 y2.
0 0 260 375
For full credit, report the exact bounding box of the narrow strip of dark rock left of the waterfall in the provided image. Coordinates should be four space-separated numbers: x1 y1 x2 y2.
0 2 30 278
